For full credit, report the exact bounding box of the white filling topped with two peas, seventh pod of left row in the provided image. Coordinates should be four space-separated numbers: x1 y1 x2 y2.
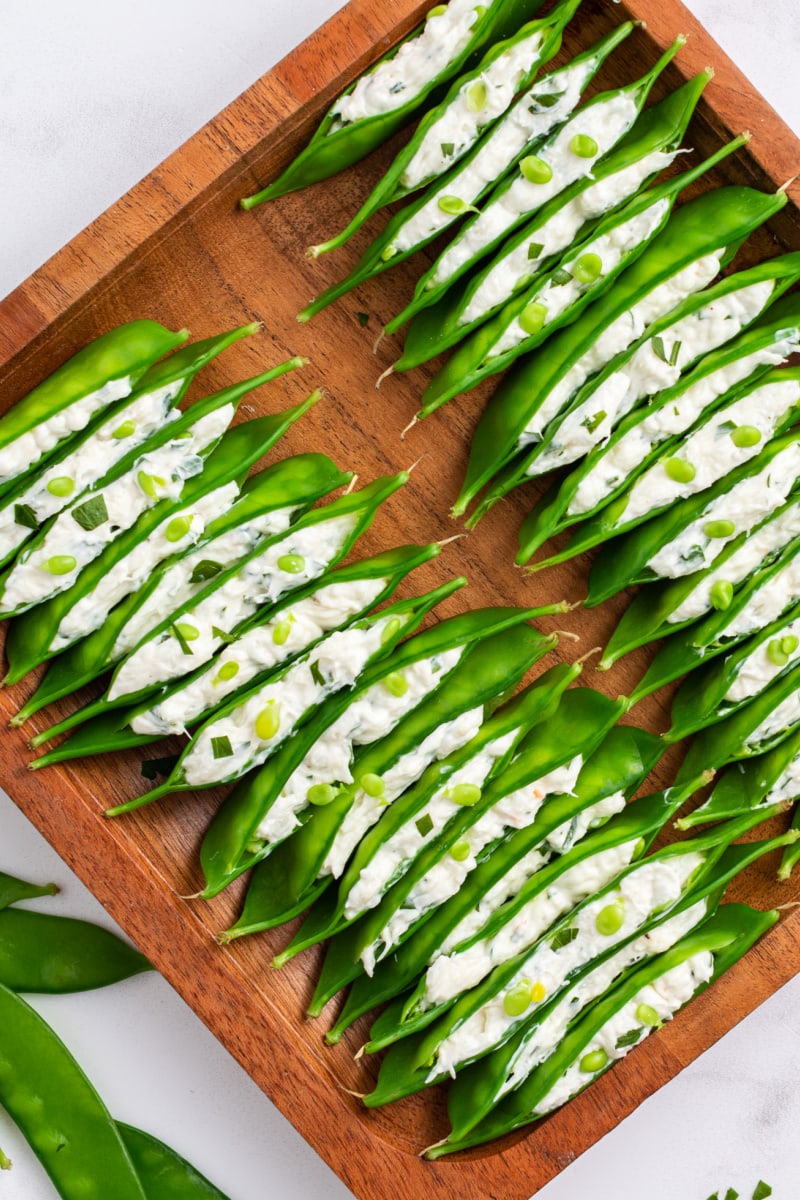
130 580 387 737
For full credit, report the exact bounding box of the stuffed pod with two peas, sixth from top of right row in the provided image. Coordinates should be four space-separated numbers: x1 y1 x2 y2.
419 137 747 416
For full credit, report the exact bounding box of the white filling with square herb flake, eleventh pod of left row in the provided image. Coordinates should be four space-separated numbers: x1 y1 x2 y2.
344 732 516 920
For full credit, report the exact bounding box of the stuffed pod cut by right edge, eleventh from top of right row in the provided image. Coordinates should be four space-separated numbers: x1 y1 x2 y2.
582 432 800 607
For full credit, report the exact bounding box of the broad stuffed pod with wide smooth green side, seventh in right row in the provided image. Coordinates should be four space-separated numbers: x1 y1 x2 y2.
453 187 786 520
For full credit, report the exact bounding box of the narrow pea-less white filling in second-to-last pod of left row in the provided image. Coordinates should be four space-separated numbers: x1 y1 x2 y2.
498 900 708 1098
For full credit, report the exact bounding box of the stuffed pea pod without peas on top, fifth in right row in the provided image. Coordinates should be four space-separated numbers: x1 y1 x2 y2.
386 70 711 371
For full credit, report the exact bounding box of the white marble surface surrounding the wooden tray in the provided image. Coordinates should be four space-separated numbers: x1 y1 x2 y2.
0 0 800 1200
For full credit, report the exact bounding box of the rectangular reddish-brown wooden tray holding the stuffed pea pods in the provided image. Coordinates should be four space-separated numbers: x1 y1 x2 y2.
0 0 800 1200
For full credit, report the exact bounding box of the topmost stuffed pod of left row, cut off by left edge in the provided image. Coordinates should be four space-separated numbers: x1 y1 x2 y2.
0 320 188 493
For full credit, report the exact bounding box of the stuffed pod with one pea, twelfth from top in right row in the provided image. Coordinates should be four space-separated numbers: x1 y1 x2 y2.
600 497 800 676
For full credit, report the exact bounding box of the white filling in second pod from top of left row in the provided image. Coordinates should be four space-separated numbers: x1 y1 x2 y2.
0 380 181 559
